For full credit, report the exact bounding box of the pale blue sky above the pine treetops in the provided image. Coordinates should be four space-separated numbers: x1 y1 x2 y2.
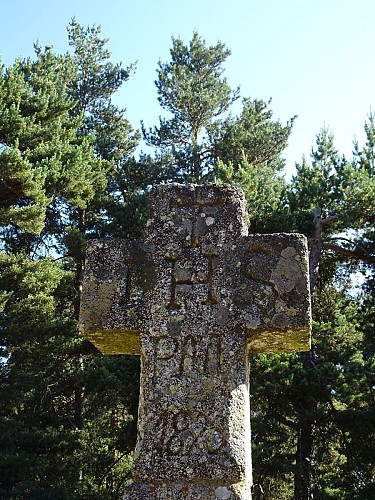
0 0 375 174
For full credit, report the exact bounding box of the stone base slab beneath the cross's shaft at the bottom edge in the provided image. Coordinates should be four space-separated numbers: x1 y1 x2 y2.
123 482 251 500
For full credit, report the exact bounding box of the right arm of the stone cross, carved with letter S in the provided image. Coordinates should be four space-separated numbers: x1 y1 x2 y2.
235 233 311 353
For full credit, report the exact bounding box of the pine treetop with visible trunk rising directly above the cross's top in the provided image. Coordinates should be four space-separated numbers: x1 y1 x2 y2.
143 32 239 182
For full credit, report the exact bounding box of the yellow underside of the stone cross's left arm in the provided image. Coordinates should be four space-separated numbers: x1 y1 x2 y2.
82 330 141 355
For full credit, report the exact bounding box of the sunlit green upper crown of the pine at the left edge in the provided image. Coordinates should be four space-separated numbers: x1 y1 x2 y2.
0 47 105 244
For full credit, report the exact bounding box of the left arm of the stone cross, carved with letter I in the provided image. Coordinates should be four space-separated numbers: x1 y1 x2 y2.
79 239 156 354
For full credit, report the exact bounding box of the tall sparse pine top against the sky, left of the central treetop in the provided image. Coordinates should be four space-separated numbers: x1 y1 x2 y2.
68 19 140 161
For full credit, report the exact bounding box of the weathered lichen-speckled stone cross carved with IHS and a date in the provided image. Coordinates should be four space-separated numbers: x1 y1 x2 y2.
80 184 310 500
